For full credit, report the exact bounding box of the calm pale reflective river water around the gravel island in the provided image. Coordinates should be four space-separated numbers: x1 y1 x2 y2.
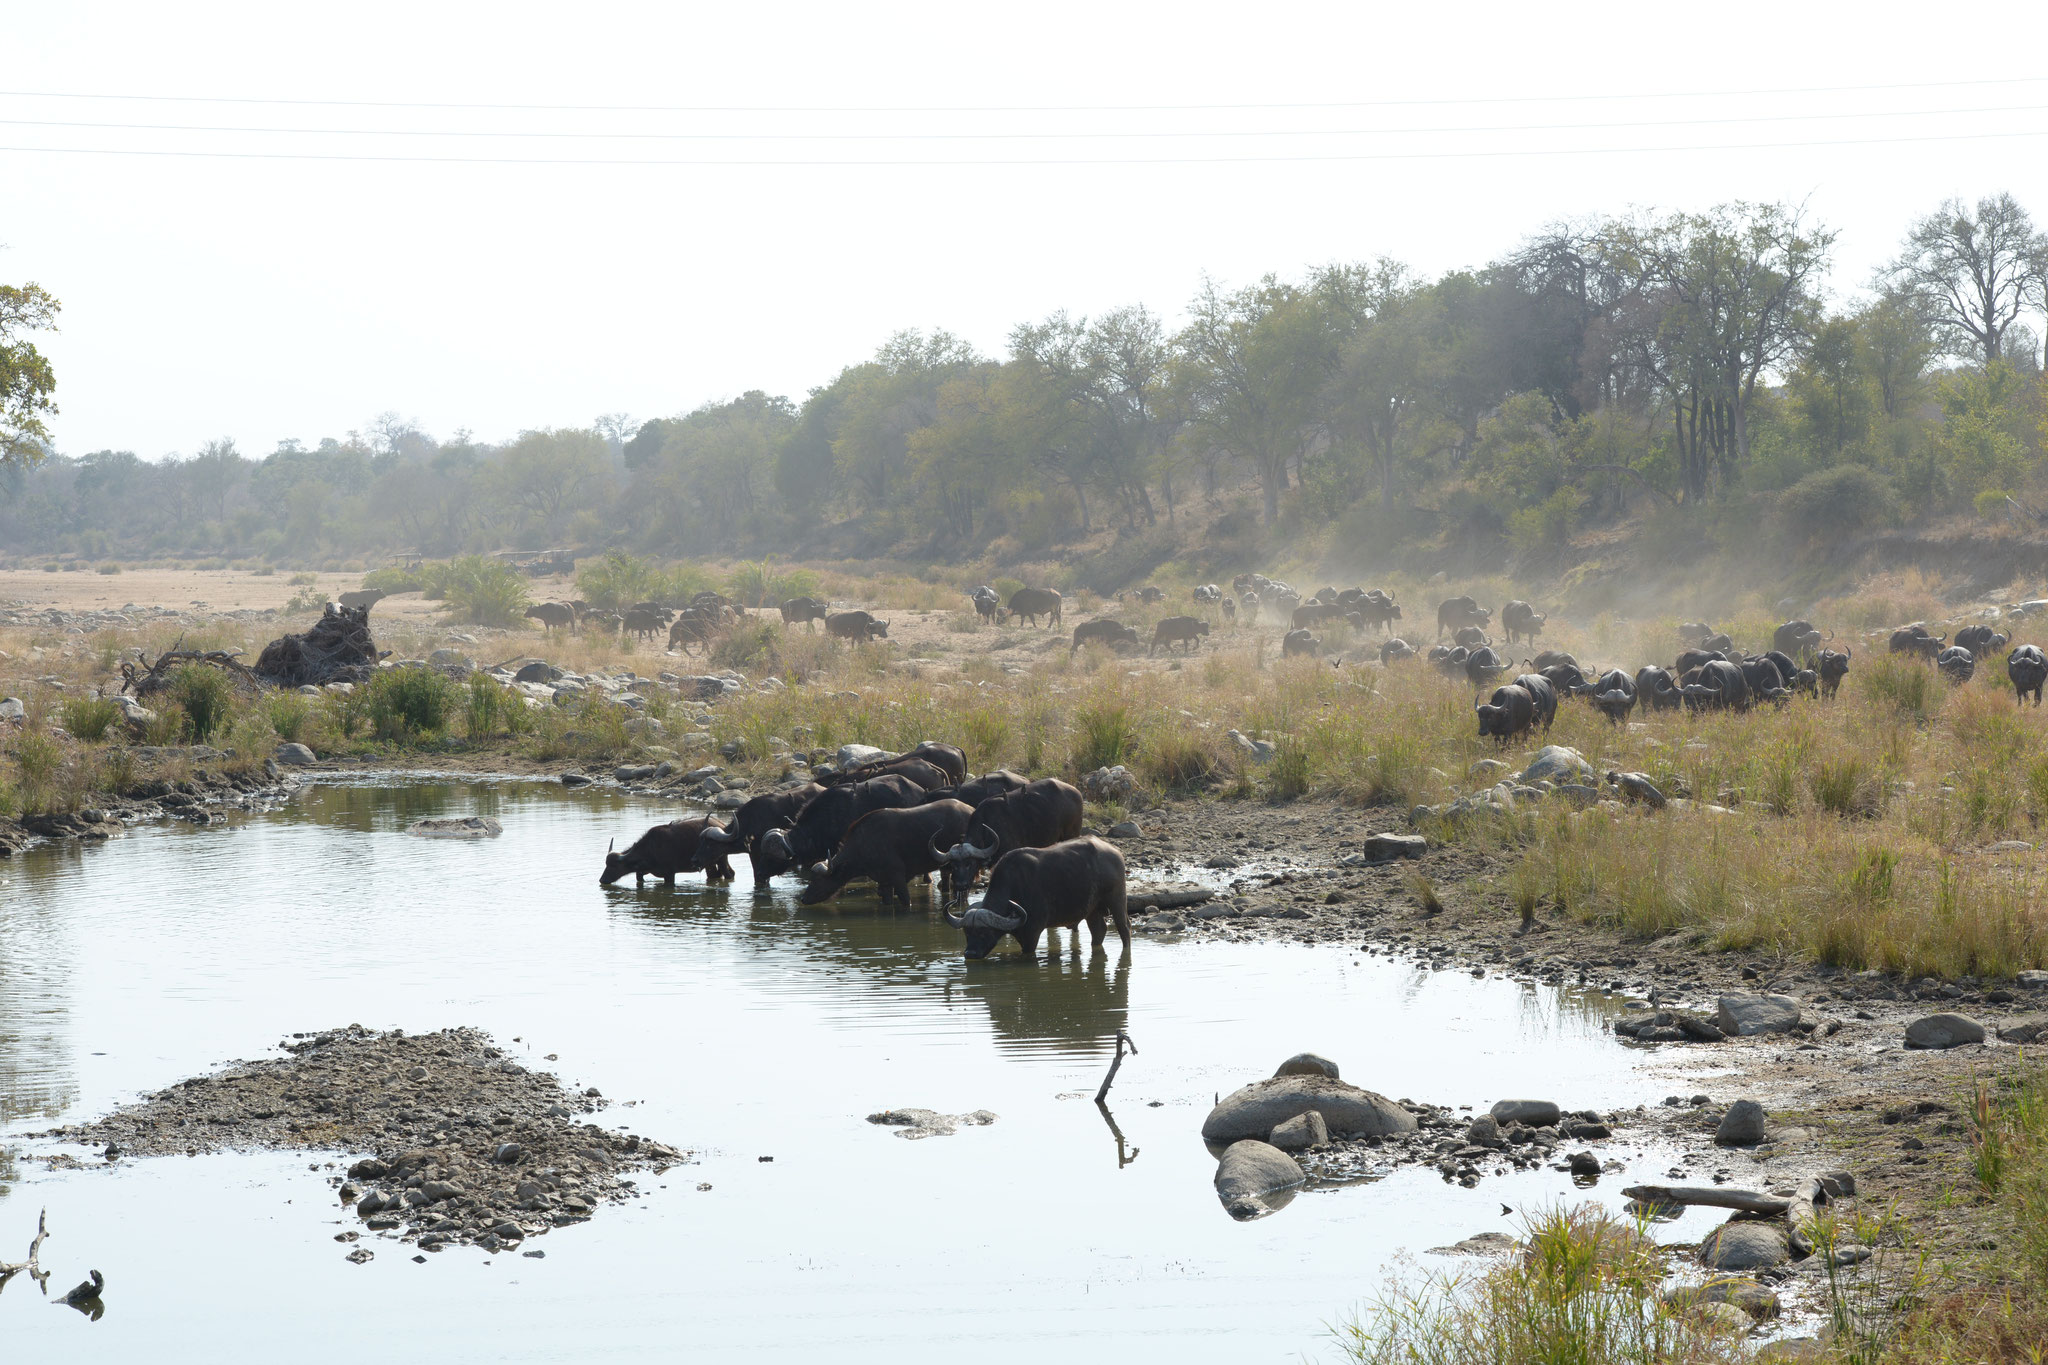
0 782 1728 1365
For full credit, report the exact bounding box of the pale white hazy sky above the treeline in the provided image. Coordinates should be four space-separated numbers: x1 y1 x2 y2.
0 0 2048 456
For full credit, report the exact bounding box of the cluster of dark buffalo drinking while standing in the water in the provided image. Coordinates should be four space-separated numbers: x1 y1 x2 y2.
598 743 1130 958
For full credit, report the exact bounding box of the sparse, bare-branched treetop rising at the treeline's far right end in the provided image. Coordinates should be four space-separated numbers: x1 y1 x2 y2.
1882 192 2048 364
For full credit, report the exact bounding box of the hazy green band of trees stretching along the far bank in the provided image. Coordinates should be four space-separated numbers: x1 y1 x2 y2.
0 194 2048 573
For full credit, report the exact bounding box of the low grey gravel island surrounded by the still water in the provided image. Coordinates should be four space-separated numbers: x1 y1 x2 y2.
31 1025 688 1261
